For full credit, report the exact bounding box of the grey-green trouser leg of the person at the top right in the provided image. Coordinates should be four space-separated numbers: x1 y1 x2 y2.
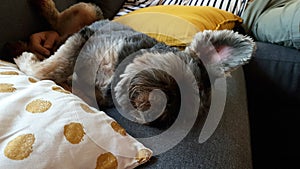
242 0 300 49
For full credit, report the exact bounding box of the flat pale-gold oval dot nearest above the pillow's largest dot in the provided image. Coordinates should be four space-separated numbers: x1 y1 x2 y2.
26 99 52 113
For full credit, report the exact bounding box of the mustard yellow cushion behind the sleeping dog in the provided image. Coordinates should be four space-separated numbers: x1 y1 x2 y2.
114 5 242 47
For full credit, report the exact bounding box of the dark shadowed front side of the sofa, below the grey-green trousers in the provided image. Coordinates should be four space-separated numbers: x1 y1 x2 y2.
244 42 300 168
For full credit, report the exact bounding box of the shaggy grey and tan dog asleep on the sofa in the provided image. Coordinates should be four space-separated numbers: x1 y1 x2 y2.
15 20 255 125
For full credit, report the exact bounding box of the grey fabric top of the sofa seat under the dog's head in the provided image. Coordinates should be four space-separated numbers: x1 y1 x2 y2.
106 69 252 169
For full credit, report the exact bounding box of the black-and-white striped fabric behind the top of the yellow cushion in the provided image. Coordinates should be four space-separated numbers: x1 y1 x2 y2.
116 0 248 17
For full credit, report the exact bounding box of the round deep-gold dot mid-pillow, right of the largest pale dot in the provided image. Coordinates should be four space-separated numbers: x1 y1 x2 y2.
64 123 85 144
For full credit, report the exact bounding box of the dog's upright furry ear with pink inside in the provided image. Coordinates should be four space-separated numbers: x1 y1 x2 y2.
185 30 255 77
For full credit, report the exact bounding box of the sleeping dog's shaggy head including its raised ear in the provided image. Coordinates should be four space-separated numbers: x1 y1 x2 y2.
113 31 255 127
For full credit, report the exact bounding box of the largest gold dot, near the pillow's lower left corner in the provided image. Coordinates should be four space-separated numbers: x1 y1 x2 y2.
4 134 35 160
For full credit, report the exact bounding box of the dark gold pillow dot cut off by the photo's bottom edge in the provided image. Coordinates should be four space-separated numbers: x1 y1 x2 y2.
96 152 118 169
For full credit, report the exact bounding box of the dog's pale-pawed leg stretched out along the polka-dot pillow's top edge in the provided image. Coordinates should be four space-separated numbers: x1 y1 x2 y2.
15 27 94 83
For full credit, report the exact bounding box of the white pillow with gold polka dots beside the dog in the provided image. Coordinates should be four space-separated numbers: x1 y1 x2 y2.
0 61 152 169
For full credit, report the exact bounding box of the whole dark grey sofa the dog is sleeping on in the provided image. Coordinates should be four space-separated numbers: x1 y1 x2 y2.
0 0 300 169
